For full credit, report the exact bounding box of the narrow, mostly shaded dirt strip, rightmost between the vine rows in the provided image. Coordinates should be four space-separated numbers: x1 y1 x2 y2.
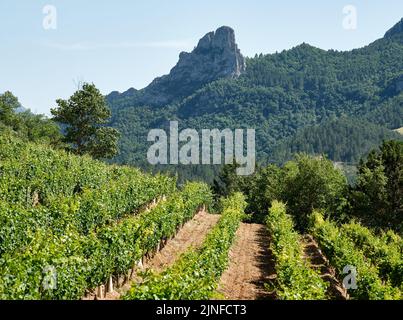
301 235 348 300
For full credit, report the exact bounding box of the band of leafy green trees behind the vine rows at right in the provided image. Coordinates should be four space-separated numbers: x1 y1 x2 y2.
213 140 403 234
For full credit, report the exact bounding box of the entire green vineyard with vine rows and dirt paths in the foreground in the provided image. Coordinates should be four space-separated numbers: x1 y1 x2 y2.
0 136 403 300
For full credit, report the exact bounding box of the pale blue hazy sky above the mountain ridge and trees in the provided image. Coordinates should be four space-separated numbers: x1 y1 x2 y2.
0 0 403 114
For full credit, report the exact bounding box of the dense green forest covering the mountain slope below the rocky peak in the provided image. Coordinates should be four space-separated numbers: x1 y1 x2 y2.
107 21 403 181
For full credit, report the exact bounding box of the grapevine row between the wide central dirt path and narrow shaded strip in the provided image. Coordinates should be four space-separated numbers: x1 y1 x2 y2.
266 201 327 300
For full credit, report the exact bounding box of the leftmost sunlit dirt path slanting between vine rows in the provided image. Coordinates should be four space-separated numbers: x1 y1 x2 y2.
102 211 220 300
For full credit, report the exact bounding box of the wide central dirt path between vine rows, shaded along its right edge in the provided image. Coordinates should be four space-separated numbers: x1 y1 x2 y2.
218 223 275 300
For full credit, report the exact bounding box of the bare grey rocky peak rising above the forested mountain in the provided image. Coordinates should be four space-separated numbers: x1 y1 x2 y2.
126 27 246 106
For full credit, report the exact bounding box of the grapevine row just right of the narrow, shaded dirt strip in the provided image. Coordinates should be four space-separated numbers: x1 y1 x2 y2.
310 212 402 300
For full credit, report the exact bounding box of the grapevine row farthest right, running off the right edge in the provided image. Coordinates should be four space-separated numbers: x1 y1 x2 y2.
341 222 403 289
